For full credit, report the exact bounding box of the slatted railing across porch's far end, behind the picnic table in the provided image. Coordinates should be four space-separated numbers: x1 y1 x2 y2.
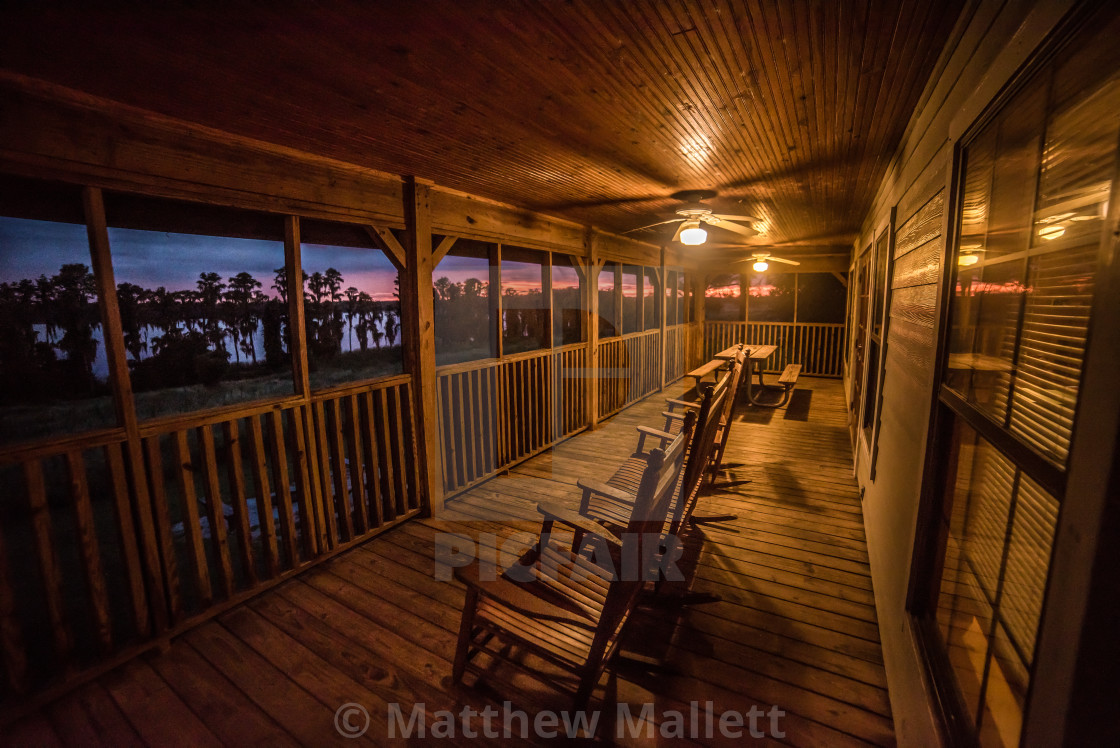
704 321 844 377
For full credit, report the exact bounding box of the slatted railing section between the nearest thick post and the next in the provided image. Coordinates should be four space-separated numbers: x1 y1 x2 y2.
436 344 588 494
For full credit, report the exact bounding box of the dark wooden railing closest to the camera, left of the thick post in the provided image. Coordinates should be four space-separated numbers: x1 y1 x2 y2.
0 376 420 693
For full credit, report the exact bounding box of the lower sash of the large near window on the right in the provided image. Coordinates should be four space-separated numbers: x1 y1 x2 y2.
937 422 1057 745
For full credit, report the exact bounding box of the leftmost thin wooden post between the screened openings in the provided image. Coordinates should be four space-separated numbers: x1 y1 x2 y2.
82 187 169 635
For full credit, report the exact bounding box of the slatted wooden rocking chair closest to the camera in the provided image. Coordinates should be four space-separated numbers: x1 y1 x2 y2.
451 415 696 709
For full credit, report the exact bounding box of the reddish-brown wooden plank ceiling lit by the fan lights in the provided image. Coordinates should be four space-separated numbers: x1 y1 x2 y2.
0 0 963 263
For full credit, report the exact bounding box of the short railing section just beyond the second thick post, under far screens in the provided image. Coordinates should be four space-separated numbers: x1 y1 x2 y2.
597 330 661 417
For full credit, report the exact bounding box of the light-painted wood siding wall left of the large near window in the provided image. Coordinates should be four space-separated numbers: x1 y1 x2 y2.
849 1 1072 745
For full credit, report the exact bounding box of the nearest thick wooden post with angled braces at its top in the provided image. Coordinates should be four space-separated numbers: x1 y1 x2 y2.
401 177 441 516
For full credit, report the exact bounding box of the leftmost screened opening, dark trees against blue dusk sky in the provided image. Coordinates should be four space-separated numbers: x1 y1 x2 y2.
0 193 115 442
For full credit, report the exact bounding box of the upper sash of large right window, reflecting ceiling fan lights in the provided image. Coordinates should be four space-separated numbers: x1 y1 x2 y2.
945 57 1120 467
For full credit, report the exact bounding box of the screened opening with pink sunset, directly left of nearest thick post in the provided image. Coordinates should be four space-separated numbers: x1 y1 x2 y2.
300 221 404 390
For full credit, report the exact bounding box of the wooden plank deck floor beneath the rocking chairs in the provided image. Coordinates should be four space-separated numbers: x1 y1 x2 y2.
0 378 894 747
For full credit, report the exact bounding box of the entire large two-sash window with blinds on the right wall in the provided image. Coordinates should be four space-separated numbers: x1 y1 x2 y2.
912 8 1120 746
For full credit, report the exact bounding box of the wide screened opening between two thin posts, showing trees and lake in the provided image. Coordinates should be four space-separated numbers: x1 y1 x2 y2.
106 196 293 419
